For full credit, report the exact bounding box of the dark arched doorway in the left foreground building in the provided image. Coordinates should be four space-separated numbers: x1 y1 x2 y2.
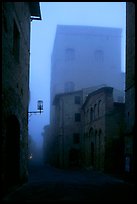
5 115 20 187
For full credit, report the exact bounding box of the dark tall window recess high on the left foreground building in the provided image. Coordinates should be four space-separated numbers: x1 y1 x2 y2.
13 21 20 62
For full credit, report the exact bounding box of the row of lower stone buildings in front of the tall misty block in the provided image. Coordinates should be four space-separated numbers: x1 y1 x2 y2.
52 87 124 173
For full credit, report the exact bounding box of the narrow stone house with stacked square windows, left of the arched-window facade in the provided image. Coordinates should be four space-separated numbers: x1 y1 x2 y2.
53 91 83 168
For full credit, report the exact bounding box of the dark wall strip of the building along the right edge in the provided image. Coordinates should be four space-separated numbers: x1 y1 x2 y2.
125 2 136 176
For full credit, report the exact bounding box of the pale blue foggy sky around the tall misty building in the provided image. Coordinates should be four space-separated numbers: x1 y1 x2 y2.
29 2 126 161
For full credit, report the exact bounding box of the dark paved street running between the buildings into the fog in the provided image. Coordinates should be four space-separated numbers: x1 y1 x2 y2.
2 165 135 204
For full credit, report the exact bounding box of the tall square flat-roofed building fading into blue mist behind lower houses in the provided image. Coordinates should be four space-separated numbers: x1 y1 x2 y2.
49 25 125 167
